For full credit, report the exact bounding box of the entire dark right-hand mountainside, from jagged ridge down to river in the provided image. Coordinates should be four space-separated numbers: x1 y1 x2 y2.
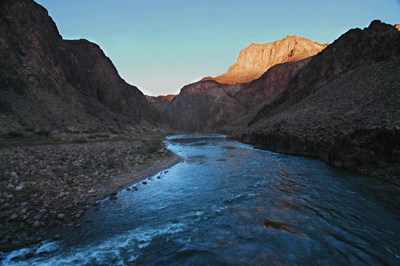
230 21 400 184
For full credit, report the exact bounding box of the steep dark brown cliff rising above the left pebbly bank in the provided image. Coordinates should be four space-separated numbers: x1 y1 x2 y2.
0 0 162 133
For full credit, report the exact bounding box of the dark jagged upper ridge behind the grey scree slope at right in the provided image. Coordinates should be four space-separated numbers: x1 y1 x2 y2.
250 21 400 124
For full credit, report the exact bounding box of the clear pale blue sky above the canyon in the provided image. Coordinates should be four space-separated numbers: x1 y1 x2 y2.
35 0 400 96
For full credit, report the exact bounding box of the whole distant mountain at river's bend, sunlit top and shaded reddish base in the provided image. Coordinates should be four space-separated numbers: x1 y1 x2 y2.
149 36 327 131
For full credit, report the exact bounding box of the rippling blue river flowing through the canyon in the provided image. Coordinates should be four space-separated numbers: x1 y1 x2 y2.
1 135 400 266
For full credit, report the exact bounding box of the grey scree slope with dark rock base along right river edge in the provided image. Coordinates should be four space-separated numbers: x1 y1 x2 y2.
228 57 400 184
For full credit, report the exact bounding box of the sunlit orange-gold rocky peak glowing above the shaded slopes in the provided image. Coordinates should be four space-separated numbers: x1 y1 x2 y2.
203 36 328 84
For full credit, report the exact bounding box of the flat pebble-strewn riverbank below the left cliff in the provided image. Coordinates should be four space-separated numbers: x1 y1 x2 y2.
0 138 182 252
